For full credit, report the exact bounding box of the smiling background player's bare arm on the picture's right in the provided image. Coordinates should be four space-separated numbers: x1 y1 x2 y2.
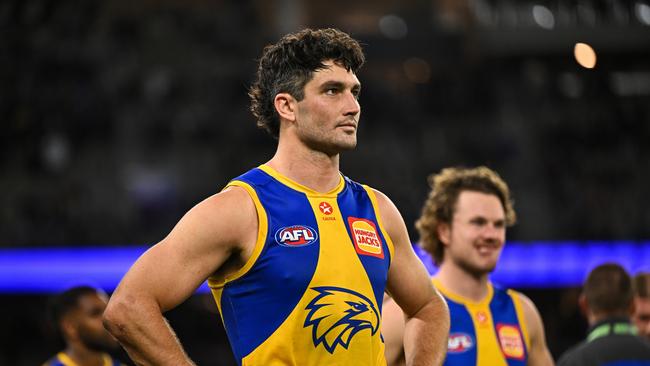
517 293 554 366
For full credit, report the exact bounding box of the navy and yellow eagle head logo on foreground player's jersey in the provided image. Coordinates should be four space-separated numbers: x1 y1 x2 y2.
304 286 379 353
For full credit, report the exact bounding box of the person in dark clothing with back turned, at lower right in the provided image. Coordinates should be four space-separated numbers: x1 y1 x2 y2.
558 263 650 366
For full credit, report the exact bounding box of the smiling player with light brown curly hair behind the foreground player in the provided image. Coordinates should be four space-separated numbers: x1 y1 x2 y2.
383 167 553 366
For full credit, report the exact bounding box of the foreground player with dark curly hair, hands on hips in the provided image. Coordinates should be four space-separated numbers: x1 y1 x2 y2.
105 29 449 366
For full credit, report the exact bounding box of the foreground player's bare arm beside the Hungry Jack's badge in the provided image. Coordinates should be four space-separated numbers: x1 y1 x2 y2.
375 191 449 365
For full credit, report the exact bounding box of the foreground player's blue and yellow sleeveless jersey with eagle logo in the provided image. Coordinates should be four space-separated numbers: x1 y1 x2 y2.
208 165 393 366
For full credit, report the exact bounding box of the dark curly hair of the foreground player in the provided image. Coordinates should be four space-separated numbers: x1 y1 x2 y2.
248 28 365 138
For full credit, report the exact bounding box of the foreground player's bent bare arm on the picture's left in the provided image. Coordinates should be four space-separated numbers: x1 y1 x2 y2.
104 187 258 365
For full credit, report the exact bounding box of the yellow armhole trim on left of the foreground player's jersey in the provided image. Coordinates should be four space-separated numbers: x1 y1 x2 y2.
208 180 268 290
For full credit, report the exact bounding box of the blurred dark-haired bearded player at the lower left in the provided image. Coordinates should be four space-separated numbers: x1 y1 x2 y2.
43 286 121 366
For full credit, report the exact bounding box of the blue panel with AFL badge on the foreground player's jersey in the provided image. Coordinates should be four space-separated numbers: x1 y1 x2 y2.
221 169 320 362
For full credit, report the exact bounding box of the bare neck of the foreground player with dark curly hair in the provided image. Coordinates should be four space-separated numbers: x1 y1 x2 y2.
267 143 341 193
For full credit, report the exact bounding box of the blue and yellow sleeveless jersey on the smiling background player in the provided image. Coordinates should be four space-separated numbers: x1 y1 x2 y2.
433 279 530 366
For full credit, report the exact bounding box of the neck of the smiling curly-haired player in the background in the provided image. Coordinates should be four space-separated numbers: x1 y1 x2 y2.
435 262 489 302
